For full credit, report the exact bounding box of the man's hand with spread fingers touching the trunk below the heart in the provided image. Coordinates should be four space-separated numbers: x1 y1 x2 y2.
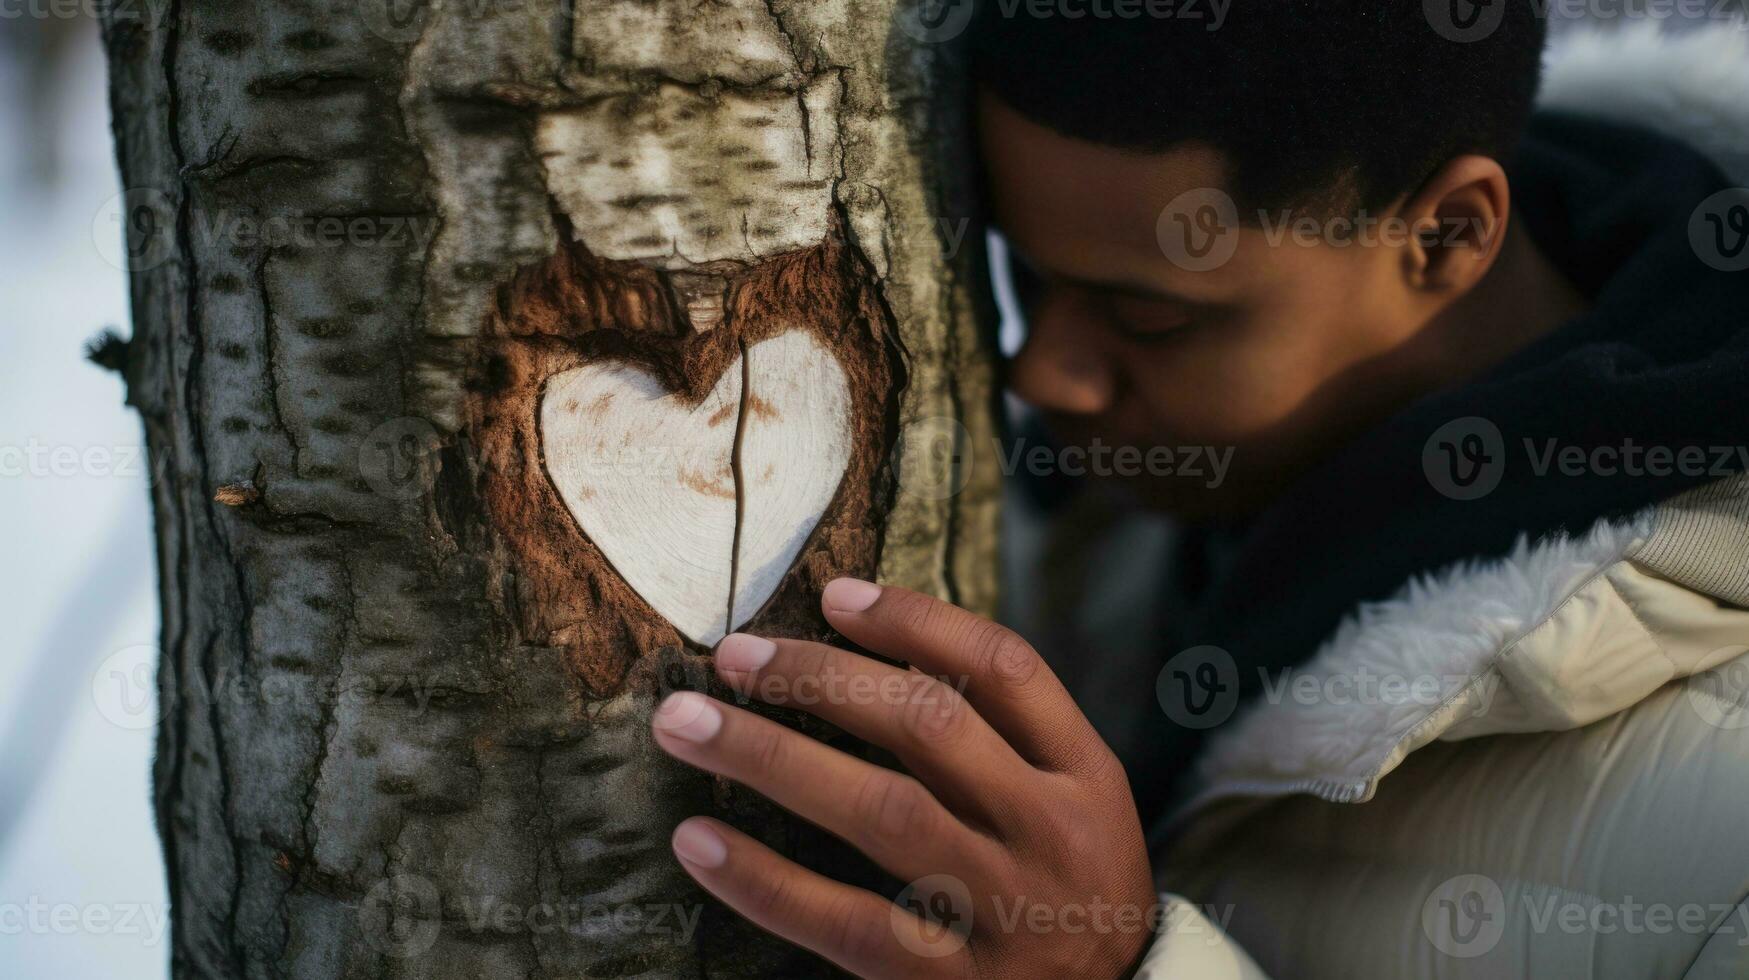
652 579 1156 980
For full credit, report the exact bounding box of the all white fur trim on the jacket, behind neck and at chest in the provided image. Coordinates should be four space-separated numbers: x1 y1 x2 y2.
1181 19 1749 816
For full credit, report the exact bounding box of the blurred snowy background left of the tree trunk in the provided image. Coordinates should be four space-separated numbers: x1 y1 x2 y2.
0 16 170 980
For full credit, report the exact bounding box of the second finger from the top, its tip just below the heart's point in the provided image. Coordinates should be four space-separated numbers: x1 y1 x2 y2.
715 634 1037 824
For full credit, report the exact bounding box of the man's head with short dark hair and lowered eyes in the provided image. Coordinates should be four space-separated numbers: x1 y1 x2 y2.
972 0 1543 513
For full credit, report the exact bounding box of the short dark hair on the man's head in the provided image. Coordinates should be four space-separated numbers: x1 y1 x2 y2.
964 0 1546 212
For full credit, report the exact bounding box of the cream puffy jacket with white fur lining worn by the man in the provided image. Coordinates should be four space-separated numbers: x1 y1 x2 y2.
1139 30 1749 980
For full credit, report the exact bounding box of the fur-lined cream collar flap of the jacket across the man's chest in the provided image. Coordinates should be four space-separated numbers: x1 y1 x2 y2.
1188 478 1749 822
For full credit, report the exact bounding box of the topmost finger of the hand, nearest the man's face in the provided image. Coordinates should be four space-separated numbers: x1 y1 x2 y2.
820 579 1111 774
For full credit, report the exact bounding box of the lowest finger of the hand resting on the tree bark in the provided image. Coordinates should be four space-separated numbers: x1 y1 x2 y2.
673 817 969 980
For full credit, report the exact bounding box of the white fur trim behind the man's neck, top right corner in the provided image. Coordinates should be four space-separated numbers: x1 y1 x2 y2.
1539 19 1749 184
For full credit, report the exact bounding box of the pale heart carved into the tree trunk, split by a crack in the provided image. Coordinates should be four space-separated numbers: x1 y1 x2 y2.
540 331 850 646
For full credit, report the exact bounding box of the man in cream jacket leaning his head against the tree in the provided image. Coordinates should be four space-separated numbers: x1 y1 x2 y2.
654 7 1749 980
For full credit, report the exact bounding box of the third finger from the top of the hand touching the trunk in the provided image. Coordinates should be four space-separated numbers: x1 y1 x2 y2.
651 691 997 880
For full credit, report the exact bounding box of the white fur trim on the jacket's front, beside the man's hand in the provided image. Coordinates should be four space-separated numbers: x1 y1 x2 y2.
1196 511 1653 805
